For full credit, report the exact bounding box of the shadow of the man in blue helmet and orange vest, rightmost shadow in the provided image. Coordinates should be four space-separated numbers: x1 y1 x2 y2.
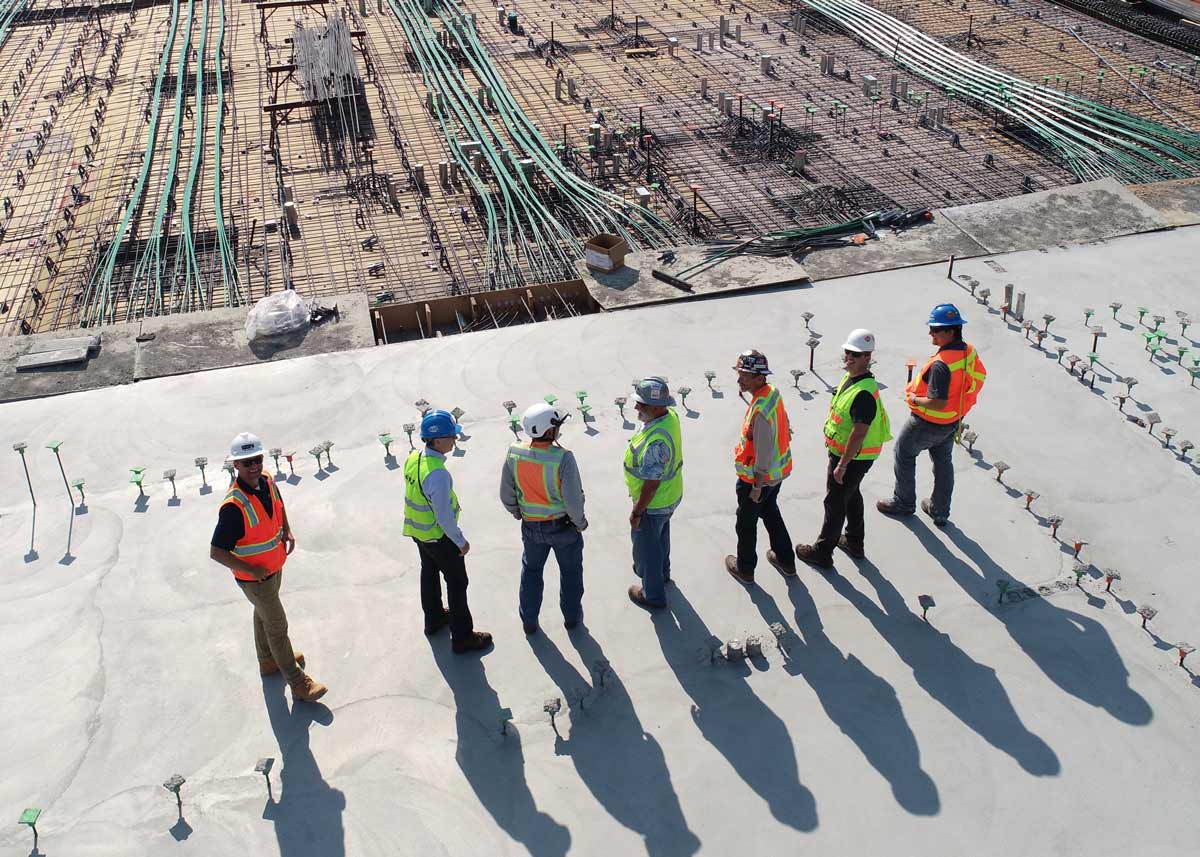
905 519 1154 726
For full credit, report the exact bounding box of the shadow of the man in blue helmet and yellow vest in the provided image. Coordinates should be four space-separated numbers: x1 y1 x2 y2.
430 639 571 857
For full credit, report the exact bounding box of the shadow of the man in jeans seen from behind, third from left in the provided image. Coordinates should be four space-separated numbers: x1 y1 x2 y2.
529 627 700 857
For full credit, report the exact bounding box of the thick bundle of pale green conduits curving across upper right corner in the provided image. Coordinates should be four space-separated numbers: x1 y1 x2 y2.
802 0 1200 182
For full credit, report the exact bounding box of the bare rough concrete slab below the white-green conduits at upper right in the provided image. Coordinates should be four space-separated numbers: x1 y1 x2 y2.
941 179 1170 253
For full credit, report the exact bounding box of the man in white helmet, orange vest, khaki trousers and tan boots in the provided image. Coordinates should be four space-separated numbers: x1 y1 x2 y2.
209 432 328 702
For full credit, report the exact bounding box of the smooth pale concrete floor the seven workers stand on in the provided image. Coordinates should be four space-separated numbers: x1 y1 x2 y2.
0 229 1200 857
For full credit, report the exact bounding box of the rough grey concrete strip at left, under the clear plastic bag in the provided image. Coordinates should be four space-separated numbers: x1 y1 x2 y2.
0 293 374 402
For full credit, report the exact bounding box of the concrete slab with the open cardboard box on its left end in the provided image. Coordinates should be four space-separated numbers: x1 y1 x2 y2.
575 245 808 310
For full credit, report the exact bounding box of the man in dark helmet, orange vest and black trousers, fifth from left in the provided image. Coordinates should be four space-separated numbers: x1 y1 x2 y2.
725 350 796 586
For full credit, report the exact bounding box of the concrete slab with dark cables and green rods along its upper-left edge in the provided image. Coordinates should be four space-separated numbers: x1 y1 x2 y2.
804 211 988 280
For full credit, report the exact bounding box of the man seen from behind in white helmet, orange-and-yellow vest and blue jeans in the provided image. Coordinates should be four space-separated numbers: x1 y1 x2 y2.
500 402 588 634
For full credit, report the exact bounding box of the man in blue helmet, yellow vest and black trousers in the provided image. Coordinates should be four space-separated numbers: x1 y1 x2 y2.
403 410 492 654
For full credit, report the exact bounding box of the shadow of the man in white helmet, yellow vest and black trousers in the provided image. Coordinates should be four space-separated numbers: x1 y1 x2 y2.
830 559 1062 777
